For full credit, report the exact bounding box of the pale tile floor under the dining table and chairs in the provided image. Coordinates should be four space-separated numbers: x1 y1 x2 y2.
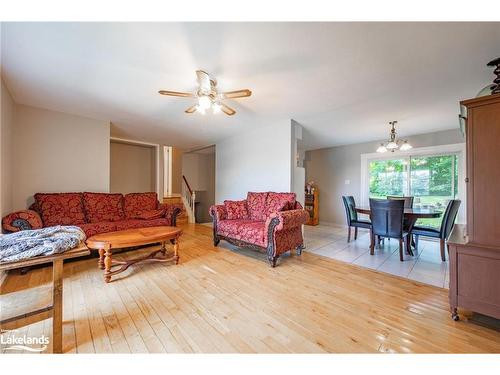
304 225 449 288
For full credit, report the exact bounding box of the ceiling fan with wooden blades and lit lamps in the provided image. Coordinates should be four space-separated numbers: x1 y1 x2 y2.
158 70 252 116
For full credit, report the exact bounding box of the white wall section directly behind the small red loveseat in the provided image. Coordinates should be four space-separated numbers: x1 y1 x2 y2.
215 120 292 203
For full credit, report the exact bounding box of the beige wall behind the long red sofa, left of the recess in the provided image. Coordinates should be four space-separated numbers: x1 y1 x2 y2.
12 105 110 210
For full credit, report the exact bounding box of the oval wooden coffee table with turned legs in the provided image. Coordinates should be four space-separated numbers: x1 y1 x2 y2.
86 226 182 283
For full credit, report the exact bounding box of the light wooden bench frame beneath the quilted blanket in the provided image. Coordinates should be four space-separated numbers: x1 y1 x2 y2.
0 244 90 353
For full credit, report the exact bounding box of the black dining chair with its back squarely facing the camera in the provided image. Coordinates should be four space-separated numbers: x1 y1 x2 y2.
370 198 411 262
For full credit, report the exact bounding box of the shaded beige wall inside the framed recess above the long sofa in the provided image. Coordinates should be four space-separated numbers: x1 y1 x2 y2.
110 141 156 194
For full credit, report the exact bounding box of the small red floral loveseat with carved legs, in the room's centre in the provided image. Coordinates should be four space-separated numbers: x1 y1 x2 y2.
210 192 308 267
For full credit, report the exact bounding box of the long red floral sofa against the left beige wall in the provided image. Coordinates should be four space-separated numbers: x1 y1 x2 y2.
2 192 182 237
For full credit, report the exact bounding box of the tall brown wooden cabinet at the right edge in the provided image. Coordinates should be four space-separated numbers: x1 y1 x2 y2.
448 94 500 319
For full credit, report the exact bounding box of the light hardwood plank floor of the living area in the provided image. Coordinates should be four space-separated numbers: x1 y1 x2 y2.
0 224 500 353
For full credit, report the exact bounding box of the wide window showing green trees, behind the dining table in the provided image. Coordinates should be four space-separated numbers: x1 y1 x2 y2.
368 153 459 228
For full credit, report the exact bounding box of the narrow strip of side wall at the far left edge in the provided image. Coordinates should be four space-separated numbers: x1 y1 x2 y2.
0 80 15 217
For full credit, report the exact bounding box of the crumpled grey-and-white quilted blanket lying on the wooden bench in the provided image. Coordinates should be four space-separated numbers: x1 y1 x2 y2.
0 225 86 262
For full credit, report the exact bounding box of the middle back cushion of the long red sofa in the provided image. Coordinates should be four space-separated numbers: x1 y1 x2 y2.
83 193 125 223
